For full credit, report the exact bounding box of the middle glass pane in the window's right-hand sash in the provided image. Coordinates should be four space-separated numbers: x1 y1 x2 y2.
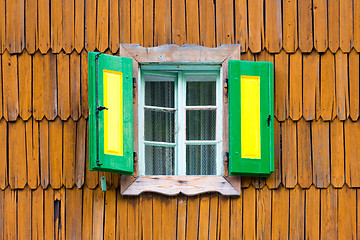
186 110 216 140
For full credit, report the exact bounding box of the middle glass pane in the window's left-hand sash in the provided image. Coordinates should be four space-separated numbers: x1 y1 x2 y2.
145 109 175 143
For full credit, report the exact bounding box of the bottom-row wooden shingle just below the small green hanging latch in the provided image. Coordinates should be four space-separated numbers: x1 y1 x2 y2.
92 188 104 239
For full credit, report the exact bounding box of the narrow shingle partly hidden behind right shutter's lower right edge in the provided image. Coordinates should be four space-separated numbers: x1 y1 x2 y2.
266 119 282 189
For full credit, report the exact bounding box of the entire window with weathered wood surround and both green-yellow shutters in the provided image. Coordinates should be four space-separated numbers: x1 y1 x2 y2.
89 44 274 195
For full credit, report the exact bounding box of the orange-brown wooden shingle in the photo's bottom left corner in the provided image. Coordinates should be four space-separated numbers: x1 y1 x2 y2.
3 188 17 239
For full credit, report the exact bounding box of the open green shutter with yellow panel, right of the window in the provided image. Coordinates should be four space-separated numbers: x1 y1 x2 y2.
228 60 274 176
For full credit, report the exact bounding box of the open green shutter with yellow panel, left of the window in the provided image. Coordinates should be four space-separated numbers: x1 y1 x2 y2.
88 52 133 174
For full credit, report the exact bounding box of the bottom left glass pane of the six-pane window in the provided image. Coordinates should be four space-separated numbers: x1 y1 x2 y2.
145 146 175 175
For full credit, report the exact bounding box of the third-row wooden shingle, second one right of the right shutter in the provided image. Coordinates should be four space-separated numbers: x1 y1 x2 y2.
282 120 297 188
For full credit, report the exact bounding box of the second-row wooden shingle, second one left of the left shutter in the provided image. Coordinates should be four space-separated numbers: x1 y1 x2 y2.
70 52 81 121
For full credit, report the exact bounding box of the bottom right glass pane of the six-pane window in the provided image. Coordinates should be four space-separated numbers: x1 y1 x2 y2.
186 145 216 175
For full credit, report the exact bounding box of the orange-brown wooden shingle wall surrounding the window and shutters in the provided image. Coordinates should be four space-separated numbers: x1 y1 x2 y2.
0 0 360 239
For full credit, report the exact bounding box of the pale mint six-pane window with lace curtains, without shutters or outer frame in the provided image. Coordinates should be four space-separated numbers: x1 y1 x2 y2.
138 65 223 175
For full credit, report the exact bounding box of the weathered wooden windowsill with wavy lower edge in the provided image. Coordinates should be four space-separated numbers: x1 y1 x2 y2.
122 176 240 196
